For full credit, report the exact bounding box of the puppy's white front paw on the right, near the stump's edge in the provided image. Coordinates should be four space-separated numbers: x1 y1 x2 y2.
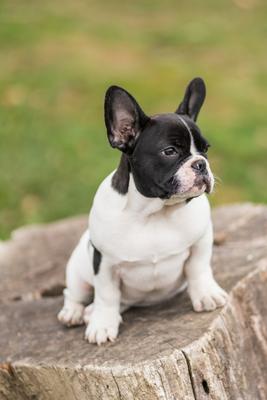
188 279 228 312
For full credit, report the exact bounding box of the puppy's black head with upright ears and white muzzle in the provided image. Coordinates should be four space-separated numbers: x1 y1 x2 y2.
105 78 214 200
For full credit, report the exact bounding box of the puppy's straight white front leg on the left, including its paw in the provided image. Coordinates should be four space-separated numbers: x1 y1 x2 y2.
85 258 122 345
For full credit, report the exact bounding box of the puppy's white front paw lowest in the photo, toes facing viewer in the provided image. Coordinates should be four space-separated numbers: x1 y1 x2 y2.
85 308 122 345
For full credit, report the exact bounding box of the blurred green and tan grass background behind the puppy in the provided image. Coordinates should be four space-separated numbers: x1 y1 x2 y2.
0 0 267 238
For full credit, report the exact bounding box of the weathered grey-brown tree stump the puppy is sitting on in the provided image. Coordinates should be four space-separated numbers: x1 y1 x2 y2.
0 204 267 400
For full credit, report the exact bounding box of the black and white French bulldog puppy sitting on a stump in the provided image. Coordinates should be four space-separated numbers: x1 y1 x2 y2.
58 78 227 344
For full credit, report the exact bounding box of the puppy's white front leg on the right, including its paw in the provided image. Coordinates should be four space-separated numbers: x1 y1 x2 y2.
185 224 228 312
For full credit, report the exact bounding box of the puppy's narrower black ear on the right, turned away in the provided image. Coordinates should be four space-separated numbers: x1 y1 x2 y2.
175 78 206 121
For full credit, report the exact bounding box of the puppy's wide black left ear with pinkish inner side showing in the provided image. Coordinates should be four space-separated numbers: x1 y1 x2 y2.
105 86 149 154
